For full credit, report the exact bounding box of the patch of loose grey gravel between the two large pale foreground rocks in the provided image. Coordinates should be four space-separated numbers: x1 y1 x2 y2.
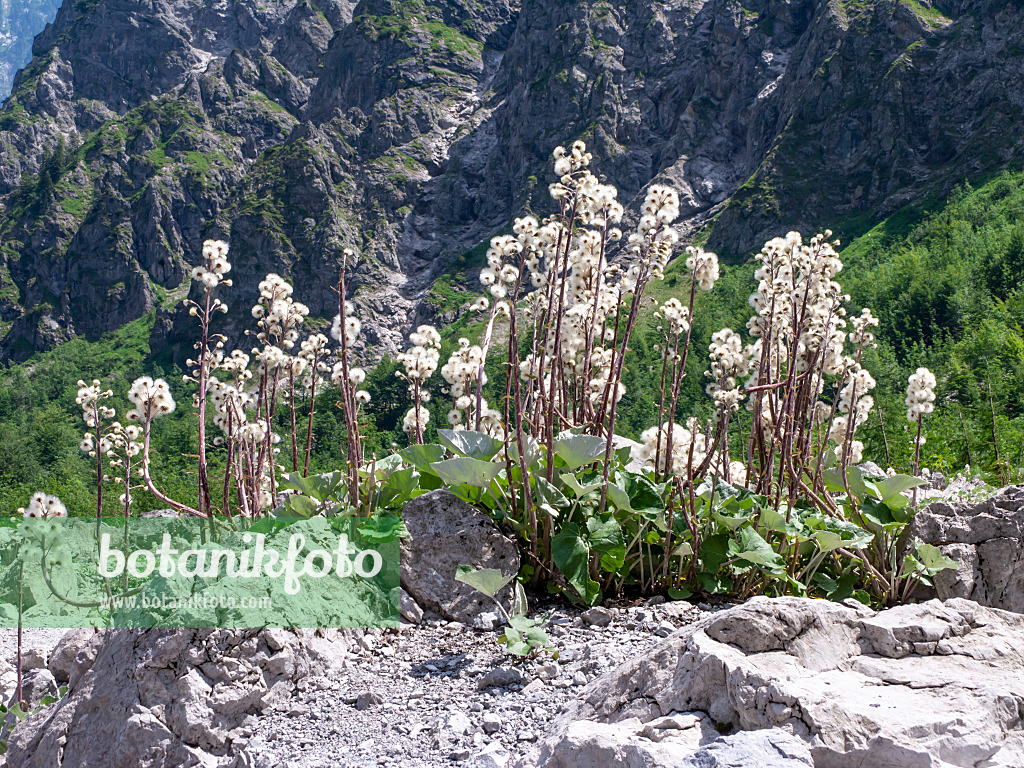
246 602 707 768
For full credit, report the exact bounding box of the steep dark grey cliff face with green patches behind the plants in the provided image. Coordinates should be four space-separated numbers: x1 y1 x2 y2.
0 0 1024 358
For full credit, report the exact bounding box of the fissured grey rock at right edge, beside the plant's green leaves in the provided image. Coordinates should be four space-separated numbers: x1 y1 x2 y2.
911 486 1024 613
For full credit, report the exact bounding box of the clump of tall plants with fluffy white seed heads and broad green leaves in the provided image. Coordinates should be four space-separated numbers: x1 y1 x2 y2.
14 141 949 618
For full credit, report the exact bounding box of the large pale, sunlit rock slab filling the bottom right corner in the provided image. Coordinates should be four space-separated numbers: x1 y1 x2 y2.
536 598 1024 768
